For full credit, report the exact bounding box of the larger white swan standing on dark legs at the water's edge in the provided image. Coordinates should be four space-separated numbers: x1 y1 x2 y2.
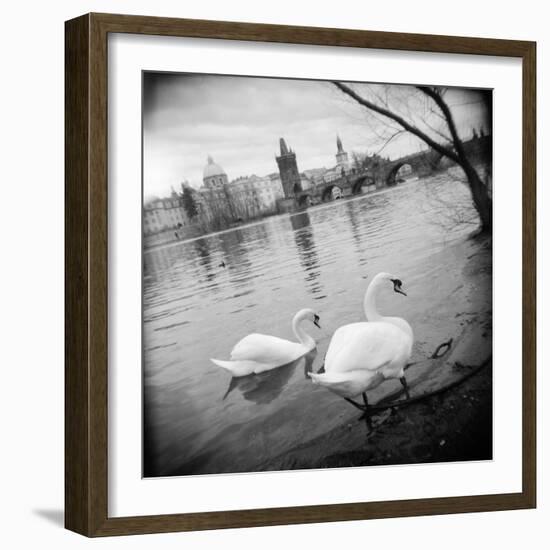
309 272 414 413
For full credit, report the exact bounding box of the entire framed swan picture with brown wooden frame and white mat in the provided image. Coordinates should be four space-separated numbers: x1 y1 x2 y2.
65 14 536 536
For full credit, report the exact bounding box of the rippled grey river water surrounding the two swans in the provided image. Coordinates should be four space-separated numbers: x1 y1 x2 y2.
143 172 492 476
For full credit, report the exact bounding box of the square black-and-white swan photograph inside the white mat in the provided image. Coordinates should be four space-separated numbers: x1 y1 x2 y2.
142 71 494 478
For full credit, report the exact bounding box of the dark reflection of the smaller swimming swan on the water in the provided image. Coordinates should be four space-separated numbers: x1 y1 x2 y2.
223 349 317 405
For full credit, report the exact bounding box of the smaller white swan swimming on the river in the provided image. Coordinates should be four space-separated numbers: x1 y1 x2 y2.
210 309 321 377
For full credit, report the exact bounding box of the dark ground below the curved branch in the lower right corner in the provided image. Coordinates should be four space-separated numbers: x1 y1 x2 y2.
261 364 493 470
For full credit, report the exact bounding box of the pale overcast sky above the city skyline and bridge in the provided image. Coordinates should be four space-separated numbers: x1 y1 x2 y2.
143 73 489 201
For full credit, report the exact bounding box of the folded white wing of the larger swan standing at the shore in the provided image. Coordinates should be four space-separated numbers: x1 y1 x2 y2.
325 322 410 372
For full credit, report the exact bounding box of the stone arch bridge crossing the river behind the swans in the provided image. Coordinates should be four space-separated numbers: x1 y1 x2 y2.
296 150 441 207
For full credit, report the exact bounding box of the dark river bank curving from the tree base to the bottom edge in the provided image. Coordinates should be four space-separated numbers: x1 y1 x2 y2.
258 237 493 471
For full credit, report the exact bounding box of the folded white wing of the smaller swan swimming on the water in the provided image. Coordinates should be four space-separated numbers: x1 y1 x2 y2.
231 334 300 365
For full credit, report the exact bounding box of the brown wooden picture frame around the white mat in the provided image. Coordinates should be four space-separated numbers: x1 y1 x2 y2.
65 14 536 536
